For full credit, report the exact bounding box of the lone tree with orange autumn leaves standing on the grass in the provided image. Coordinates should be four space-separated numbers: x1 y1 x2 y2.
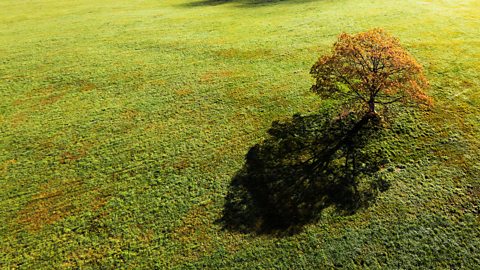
310 29 431 117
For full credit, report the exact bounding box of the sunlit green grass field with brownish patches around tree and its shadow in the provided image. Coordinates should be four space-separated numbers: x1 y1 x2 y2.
0 0 480 269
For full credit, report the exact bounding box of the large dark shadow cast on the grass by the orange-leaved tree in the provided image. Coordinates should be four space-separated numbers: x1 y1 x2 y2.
220 110 389 234
